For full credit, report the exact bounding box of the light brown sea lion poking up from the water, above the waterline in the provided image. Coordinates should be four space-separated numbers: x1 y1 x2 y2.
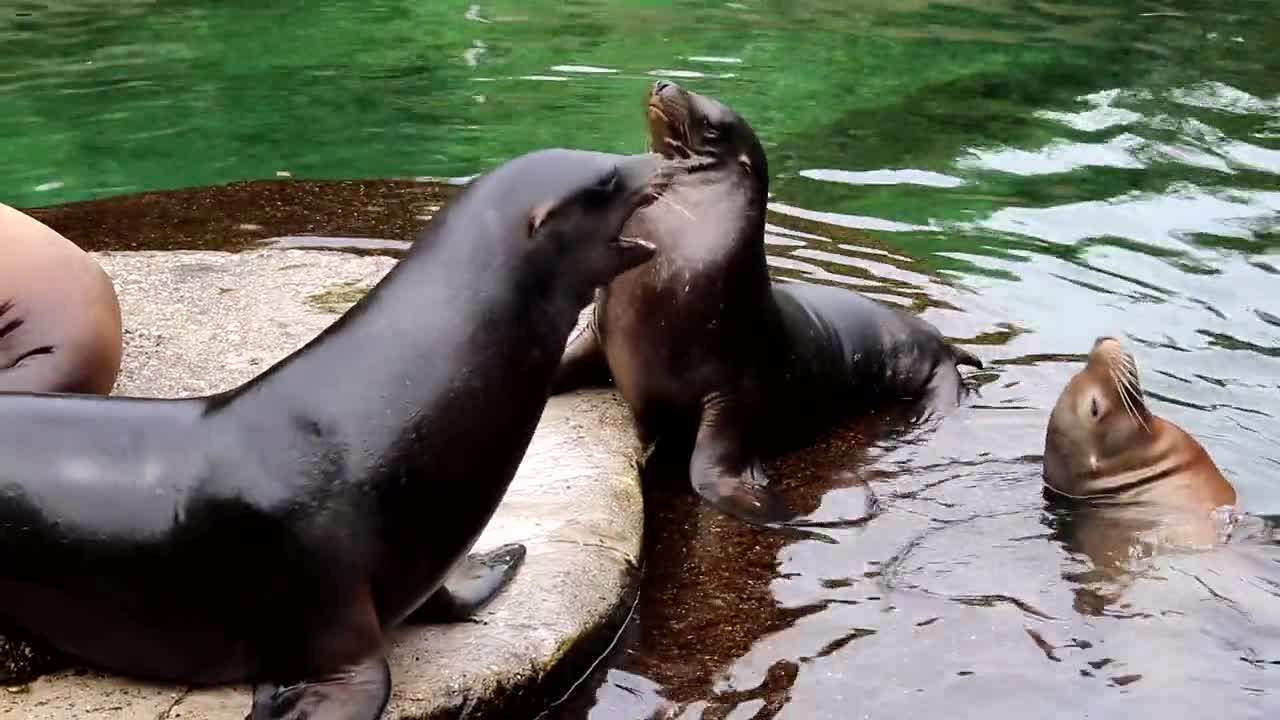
1044 337 1235 510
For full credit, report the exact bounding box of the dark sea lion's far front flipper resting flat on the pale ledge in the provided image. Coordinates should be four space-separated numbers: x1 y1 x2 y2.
406 543 526 624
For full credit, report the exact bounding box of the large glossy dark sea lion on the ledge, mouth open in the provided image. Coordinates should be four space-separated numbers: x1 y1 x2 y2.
0 150 667 720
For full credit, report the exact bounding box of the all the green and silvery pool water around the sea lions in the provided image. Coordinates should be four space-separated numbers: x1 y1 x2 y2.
0 0 1280 720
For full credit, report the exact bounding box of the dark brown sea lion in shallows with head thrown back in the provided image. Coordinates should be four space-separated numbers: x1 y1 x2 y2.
554 81 982 525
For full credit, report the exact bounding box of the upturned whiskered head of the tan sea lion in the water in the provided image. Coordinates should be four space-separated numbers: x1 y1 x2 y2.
1044 337 1153 498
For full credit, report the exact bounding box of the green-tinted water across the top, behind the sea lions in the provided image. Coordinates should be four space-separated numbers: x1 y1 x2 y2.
0 0 1280 222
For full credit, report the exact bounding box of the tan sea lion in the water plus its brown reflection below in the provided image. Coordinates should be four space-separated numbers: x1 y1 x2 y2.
1043 337 1236 614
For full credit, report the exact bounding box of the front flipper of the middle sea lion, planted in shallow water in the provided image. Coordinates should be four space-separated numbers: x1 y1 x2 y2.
689 398 795 525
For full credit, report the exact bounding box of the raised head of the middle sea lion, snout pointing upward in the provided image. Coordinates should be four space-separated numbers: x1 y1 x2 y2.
648 79 769 183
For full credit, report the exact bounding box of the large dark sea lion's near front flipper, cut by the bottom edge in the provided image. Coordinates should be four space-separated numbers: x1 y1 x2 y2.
246 655 392 720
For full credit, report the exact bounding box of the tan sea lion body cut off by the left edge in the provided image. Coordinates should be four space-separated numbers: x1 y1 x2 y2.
0 204 123 395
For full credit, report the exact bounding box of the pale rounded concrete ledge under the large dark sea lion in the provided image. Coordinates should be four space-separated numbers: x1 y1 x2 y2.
0 250 643 720
